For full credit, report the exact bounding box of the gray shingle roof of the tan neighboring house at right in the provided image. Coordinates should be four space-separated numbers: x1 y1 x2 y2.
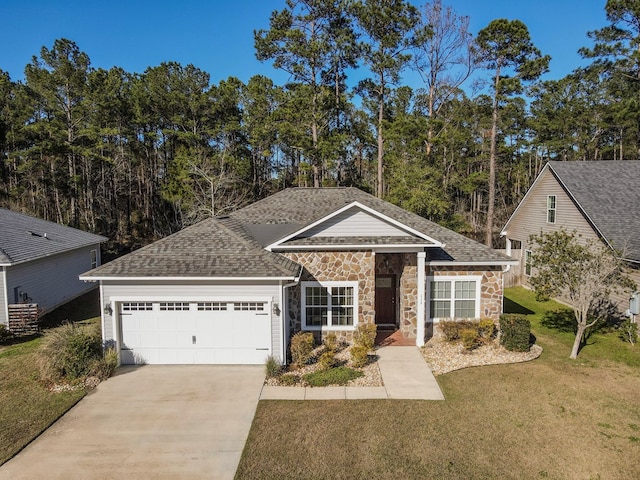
549 160 640 261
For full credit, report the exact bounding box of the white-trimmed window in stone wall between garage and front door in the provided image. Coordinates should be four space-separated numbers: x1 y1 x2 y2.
302 282 358 330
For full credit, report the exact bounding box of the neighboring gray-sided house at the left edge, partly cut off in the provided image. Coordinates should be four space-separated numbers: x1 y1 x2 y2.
0 208 107 325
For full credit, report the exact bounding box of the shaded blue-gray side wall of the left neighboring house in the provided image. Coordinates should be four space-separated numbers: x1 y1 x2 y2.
6 245 100 312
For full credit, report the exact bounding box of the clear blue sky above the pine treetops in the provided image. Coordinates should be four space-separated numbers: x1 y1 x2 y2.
0 0 606 87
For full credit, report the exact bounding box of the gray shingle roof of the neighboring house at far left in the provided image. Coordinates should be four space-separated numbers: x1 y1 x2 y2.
0 208 107 265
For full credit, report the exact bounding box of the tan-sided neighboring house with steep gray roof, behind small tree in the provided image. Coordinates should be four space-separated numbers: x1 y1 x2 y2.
501 160 640 311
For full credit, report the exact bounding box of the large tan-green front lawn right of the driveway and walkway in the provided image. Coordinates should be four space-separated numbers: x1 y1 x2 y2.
236 289 640 479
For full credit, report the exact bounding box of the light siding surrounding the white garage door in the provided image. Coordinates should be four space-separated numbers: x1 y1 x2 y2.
102 281 283 357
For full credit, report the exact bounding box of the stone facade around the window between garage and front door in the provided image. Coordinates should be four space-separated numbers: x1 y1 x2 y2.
283 251 375 342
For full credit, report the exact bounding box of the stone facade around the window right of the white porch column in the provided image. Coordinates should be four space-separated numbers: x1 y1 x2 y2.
427 266 503 324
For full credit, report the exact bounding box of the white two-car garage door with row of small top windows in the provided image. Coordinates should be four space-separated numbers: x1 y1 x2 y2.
119 301 271 364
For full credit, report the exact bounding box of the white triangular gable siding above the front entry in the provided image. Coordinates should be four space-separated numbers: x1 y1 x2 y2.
303 207 411 237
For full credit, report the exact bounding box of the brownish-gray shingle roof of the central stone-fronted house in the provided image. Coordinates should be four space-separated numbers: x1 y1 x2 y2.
82 188 512 279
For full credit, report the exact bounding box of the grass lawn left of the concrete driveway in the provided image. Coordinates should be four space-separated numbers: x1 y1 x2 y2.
0 293 99 465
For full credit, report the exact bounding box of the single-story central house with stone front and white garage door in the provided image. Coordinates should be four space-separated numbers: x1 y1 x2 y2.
81 187 516 364
